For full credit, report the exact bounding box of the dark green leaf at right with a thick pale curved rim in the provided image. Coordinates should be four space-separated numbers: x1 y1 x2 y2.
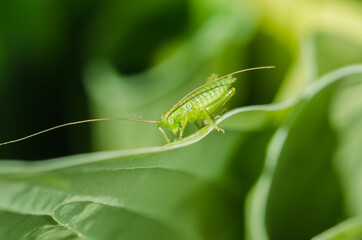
247 65 362 240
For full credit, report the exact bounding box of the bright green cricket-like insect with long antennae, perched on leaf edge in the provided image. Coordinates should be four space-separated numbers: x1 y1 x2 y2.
0 66 274 146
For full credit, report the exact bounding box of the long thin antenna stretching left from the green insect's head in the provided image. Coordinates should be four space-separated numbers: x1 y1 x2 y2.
0 118 159 146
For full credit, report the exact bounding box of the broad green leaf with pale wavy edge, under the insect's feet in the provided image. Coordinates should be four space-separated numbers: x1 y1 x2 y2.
0 66 362 239
